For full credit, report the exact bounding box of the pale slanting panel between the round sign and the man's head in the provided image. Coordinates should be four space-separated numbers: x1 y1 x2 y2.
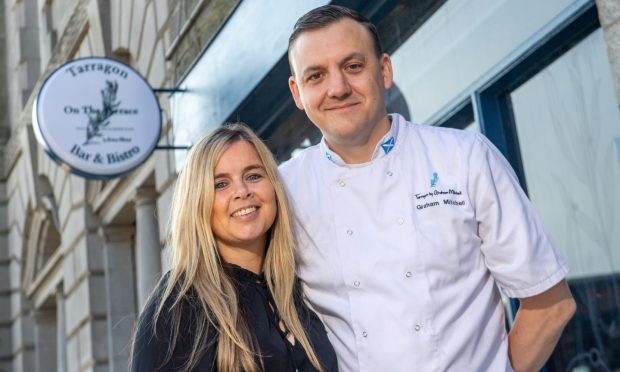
167 0 326 169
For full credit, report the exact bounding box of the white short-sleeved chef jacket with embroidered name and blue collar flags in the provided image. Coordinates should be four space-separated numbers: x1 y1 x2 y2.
280 114 568 372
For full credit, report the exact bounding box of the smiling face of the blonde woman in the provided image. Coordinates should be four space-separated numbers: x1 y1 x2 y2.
211 141 277 259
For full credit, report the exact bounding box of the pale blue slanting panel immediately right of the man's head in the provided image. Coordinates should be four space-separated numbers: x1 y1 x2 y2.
392 0 575 123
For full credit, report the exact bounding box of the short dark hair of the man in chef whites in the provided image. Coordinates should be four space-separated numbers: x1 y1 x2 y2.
288 5 383 74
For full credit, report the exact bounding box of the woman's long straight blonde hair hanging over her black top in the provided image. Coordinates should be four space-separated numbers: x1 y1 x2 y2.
153 123 322 372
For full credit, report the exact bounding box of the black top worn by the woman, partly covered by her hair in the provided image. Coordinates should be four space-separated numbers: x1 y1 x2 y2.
132 265 338 372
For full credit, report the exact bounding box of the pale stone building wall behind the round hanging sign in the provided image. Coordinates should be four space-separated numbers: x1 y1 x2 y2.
0 0 238 372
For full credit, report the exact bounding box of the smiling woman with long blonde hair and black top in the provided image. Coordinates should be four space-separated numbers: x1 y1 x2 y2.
131 124 337 372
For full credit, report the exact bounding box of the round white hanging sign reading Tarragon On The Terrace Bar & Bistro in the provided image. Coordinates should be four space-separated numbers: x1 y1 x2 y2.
32 57 161 179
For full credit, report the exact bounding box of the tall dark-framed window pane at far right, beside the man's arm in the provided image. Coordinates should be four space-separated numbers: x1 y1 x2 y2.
511 29 620 371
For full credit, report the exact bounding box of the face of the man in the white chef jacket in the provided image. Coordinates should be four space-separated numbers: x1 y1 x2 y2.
289 18 392 153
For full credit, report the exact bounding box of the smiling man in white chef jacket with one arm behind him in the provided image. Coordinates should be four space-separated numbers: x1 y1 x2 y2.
281 5 575 371
